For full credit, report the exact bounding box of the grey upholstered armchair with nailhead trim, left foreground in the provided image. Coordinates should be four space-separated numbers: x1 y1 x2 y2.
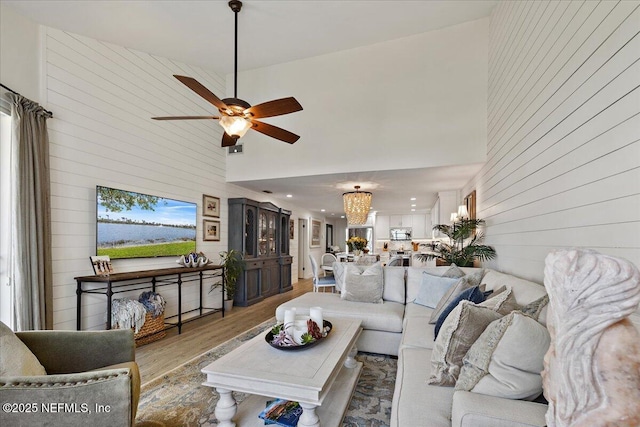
0 323 140 427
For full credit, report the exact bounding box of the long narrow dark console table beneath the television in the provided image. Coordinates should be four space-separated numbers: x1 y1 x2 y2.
74 265 224 334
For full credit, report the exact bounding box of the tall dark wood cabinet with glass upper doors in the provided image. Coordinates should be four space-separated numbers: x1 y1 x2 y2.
229 198 292 306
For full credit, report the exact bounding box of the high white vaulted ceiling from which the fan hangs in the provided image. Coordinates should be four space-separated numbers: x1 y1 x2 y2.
2 0 497 74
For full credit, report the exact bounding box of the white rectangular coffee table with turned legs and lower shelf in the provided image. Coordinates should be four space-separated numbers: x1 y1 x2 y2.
202 318 362 427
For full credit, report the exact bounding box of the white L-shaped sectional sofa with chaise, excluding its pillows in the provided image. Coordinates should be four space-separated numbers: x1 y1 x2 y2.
276 267 547 427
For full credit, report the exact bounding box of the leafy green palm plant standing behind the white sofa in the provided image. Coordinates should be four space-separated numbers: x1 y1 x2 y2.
415 218 497 267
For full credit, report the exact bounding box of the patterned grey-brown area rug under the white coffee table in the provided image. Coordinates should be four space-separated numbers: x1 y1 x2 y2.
136 319 397 427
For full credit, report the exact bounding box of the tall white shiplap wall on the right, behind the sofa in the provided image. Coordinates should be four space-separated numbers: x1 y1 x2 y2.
464 1 640 281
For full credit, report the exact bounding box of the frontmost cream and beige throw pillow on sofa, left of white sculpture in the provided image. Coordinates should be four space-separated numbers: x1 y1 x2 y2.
456 311 551 400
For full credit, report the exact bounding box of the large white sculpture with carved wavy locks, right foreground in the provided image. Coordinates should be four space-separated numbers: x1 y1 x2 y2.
542 250 640 427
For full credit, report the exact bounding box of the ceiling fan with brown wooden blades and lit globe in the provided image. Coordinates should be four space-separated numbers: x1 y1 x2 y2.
152 0 302 147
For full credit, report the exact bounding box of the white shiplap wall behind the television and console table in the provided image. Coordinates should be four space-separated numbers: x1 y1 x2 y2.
44 28 311 329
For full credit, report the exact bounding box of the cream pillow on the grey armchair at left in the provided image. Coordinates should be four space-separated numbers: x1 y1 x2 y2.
0 322 47 377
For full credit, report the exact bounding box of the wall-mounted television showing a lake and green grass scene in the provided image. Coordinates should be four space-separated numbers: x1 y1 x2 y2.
96 185 197 259
